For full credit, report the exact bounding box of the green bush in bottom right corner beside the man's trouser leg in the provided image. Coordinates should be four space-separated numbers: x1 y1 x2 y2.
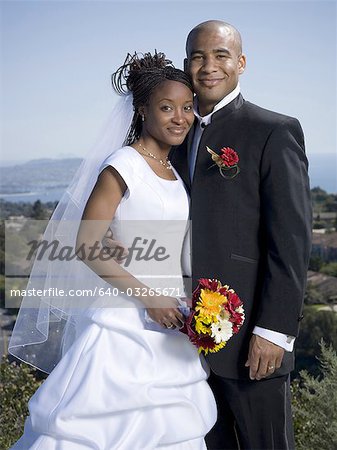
292 342 337 450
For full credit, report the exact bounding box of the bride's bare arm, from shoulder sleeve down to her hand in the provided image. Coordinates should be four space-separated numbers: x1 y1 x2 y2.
76 166 184 327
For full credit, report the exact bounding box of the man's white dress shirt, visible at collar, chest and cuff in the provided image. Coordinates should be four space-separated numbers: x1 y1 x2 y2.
189 84 295 352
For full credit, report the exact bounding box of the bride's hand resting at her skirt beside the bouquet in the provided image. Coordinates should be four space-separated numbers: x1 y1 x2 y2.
146 296 185 328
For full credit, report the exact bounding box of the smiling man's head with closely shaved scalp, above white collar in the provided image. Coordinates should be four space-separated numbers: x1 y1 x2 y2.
185 26 245 115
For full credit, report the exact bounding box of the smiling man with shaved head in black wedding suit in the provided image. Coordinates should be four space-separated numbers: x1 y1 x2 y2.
170 20 311 450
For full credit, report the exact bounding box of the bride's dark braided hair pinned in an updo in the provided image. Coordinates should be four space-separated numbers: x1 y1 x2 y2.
111 51 193 145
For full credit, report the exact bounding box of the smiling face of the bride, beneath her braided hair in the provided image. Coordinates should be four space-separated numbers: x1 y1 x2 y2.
142 80 194 146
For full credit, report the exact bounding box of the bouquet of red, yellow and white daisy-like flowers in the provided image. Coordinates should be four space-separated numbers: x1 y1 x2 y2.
180 278 245 354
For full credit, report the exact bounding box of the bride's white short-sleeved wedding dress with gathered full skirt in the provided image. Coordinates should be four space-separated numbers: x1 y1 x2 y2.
13 147 216 450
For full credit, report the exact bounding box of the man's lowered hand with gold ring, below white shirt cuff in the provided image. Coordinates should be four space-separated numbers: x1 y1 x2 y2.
245 334 284 380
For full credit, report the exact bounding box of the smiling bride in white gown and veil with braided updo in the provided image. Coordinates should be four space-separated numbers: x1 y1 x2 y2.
9 53 216 450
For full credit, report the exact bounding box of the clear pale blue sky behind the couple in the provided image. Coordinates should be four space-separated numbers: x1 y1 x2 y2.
0 0 337 164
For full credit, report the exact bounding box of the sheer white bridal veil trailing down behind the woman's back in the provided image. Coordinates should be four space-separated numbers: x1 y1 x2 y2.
8 93 134 373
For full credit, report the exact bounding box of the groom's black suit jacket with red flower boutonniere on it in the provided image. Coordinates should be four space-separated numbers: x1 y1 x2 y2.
171 95 312 378
